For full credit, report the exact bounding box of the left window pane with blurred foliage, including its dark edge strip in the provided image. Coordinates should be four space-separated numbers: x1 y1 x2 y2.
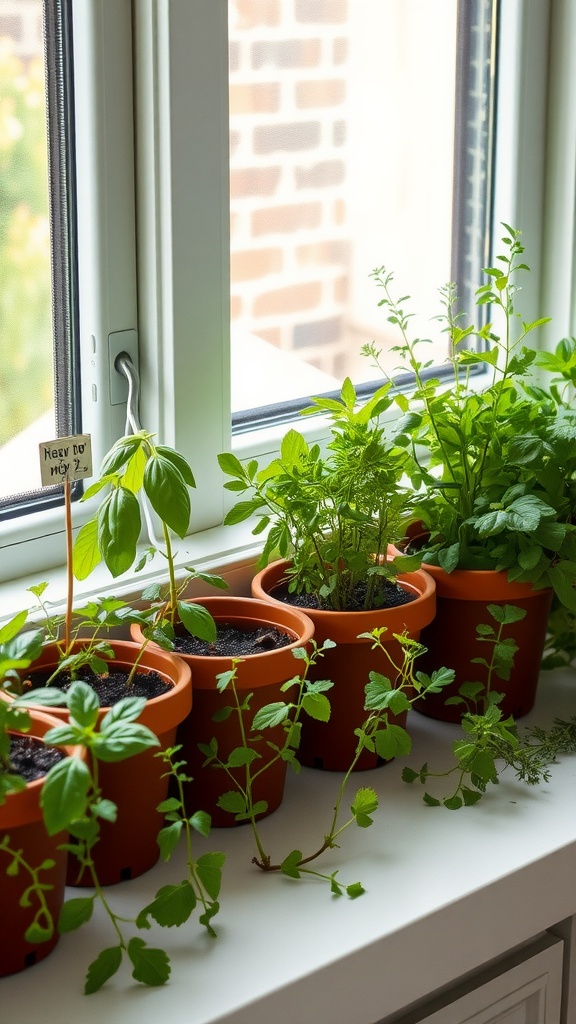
0 0 76 514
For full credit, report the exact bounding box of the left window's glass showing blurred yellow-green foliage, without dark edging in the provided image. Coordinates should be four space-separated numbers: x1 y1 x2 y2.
0 0 55 498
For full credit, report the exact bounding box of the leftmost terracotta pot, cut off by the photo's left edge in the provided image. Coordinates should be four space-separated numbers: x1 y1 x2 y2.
0 710 82 977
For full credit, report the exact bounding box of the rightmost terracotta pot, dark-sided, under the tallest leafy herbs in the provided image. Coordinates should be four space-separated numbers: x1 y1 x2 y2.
415 565 552 722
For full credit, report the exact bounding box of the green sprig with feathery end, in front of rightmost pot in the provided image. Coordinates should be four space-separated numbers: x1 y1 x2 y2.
402 604 576 810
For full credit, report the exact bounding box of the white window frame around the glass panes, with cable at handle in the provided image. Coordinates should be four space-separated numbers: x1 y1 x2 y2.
0 0 576 611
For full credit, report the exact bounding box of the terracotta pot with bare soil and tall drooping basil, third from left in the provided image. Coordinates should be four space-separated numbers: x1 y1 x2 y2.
133 597 314 827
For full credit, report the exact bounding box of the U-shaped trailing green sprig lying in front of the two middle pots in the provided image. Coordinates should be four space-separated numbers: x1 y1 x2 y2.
200 628 454 899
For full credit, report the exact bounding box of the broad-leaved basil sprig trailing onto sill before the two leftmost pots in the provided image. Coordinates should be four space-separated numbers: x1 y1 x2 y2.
41 681 223 994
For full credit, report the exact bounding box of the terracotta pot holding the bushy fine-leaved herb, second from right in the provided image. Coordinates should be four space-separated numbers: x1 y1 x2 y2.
252 560 436 771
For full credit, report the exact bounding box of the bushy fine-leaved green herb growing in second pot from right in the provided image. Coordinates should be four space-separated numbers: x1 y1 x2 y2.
218 379 420 610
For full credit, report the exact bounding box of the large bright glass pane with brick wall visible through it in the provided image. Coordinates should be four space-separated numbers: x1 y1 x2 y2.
229 0 486 419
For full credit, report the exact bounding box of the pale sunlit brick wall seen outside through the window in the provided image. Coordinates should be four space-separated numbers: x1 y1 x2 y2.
230 0 351 375
